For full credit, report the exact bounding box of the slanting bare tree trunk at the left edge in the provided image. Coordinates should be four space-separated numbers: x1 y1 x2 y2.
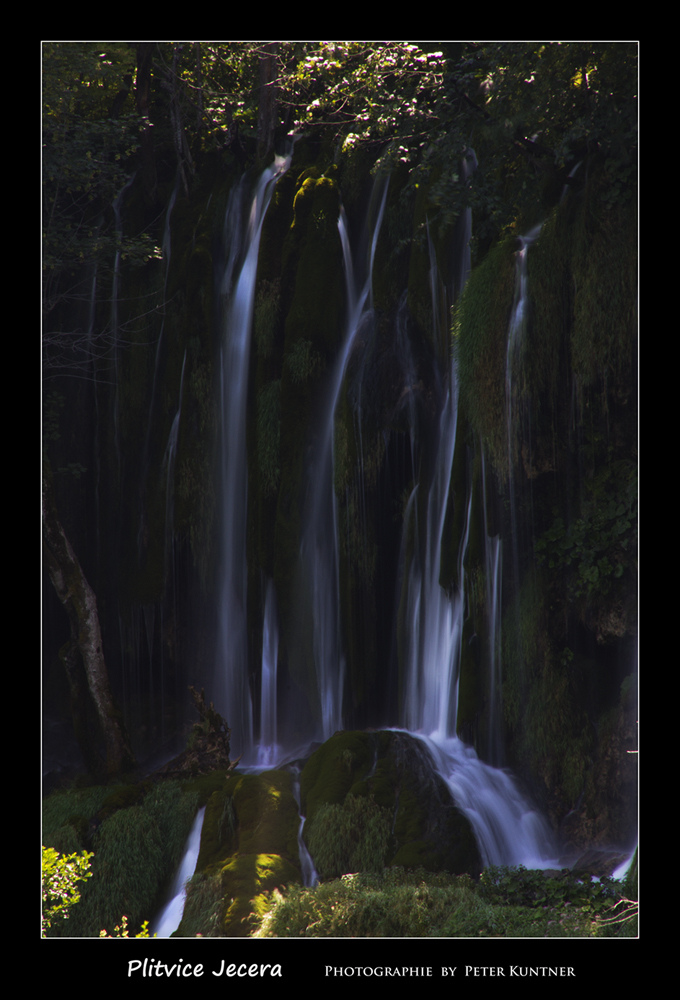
42 459 135 775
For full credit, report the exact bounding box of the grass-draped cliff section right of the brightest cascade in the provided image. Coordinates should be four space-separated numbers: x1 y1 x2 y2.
458 178 637 841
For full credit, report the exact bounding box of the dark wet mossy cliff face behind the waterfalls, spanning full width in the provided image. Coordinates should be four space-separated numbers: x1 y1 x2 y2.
46 127 636 841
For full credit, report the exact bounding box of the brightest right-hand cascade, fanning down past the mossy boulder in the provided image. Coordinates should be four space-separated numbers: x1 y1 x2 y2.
404 156 556 867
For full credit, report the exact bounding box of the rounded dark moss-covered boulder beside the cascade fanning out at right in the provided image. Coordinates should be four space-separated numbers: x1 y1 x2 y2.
301 731 481 877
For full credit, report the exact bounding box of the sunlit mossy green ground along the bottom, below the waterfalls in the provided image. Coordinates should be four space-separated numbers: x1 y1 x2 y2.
43 760 637 937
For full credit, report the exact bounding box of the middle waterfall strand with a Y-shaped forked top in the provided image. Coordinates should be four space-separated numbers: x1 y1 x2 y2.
300 180 387 740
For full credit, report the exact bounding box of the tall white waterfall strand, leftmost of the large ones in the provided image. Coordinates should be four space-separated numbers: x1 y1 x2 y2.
215 156 291 753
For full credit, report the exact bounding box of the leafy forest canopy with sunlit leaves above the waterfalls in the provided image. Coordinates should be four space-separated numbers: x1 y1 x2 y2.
43 42 638 298
